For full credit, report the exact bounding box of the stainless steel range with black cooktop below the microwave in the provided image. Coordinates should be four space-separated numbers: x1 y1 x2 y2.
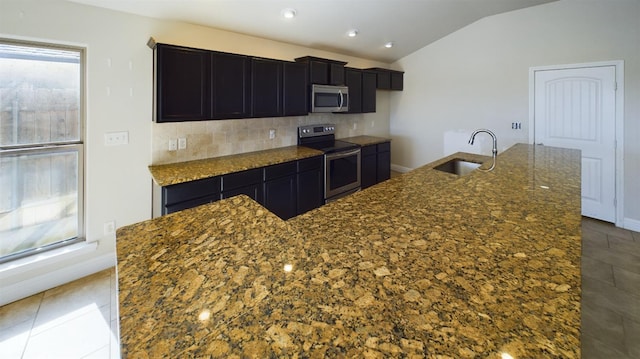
298 124 360 202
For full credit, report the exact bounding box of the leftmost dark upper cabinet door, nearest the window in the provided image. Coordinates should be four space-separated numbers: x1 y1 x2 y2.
154 44 211 122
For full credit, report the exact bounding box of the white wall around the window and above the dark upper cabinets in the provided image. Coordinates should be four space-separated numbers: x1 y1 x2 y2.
0 0 389 305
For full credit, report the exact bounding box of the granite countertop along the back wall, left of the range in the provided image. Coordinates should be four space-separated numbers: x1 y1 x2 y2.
149 146 323 186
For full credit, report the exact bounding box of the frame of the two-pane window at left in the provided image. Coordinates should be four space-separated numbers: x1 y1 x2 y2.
0 37 87 264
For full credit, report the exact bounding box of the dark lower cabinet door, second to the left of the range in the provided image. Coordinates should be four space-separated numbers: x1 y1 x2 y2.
264 173 296 219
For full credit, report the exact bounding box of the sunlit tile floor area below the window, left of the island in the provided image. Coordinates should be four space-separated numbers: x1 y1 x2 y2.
0 269 120 359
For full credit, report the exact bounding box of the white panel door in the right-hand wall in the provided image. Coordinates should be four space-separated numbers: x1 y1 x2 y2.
534 66 616 222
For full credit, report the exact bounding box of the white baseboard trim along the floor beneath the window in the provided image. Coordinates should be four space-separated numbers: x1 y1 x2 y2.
0 252 116 306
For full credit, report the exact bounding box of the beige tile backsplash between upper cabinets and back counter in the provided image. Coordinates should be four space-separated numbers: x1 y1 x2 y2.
151 114 375 165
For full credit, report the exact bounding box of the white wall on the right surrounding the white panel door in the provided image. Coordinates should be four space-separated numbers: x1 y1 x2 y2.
390 0 640 230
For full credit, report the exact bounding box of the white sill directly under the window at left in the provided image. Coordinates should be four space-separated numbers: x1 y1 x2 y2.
0 242 98 280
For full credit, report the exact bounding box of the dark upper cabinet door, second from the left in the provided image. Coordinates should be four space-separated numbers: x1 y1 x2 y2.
212 53 251 119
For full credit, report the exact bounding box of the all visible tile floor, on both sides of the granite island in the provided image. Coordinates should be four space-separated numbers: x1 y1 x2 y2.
0 219 640 359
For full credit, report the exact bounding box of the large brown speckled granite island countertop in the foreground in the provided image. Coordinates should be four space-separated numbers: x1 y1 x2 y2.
117 145 581 358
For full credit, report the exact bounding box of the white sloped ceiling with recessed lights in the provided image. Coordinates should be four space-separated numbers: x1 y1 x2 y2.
70 0 556 63
